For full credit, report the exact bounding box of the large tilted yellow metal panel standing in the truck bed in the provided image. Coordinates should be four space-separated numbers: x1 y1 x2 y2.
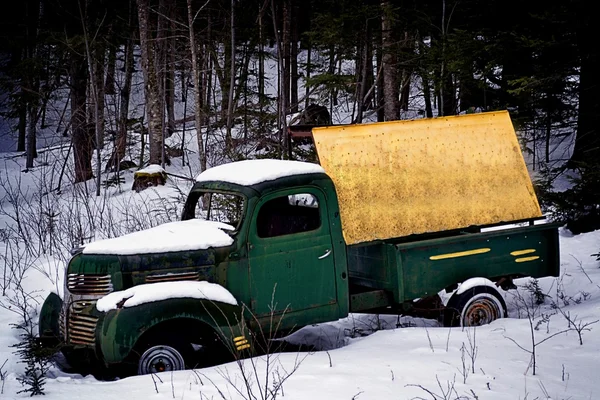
313 111 541 244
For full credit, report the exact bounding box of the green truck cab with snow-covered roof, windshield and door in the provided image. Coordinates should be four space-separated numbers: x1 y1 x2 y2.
182 160 348 332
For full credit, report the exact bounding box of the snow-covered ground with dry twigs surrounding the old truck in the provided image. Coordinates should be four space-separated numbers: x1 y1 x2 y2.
0 47 600 400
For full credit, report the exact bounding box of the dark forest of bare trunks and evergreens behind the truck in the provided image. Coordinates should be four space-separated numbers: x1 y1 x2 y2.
0 0 600 231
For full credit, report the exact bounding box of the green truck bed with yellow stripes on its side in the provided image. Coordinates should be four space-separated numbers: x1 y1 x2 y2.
347 224 559 303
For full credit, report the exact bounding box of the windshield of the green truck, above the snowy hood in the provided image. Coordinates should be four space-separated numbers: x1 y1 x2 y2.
194 192 245 230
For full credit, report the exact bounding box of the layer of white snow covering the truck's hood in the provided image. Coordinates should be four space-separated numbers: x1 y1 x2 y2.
83 219 234 255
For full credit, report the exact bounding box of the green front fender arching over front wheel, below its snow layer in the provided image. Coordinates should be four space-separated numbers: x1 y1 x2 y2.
96 298 249 365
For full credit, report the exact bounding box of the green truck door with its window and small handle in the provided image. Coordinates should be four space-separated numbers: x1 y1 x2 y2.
248 188 338 329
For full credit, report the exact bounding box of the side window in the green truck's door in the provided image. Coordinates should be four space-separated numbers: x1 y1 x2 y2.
256 193 321 238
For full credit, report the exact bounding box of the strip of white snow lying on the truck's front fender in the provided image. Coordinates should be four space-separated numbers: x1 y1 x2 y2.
96 281 237 312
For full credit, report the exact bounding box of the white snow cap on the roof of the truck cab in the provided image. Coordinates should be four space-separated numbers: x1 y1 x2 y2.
196 160 325 186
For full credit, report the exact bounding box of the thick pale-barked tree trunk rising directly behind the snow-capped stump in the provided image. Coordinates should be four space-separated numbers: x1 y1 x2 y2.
137 0 163 164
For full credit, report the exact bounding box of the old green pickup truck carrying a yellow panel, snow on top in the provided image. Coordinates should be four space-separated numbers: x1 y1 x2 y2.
39 112 559 374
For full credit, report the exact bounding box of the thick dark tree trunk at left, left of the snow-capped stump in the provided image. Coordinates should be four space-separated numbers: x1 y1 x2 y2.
69 48 94 183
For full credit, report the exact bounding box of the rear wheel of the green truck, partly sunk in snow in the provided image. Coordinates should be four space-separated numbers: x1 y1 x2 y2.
444 286 507 327
